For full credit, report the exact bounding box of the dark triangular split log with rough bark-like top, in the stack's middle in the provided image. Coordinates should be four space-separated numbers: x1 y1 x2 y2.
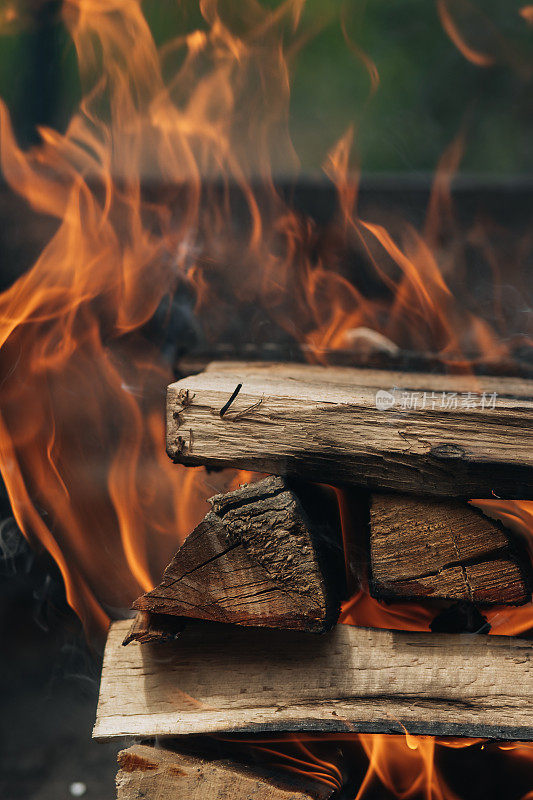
133 477 344 633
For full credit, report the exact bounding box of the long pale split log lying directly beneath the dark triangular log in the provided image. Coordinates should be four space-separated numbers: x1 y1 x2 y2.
93 622 533 740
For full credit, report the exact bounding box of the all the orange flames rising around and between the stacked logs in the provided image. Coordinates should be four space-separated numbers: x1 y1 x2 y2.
0 0 533 800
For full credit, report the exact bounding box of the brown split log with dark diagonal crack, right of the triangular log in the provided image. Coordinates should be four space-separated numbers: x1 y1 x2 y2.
370 494 532 605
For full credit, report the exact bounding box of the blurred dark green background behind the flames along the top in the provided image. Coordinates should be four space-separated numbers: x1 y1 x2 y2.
0 0 533 175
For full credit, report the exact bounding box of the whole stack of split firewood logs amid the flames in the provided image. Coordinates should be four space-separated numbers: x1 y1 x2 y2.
95 363 533 800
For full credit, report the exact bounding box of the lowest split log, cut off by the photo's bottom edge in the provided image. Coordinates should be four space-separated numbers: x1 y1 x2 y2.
117 744 333 800
